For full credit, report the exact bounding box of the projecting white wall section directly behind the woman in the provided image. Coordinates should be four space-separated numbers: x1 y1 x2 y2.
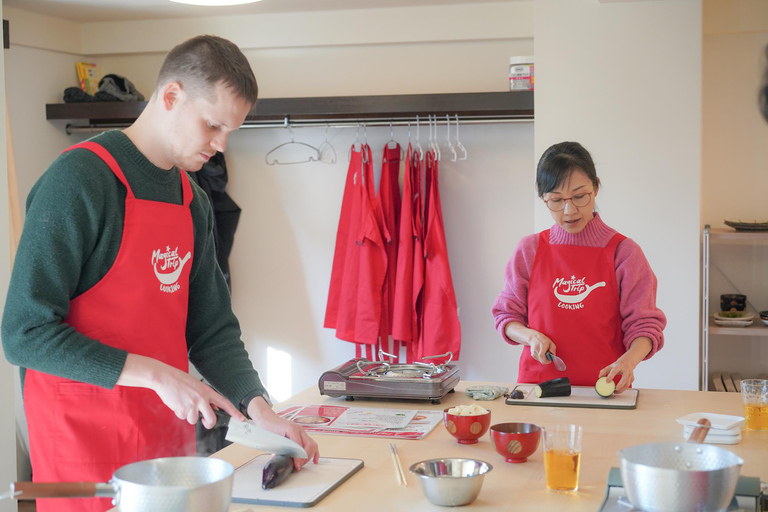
531 0 701 389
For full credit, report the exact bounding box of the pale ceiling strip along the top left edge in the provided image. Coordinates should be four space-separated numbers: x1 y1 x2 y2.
2 0 510 22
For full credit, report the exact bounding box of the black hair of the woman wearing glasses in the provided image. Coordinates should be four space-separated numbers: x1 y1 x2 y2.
536 142 600 197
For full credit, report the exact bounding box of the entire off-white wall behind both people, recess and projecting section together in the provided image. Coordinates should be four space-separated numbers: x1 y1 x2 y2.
1 0 712 440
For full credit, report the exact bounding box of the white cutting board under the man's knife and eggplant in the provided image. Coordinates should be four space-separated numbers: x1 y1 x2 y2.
232 453 363 508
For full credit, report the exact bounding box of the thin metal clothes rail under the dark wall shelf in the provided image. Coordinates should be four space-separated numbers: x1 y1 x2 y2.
66 117 533 135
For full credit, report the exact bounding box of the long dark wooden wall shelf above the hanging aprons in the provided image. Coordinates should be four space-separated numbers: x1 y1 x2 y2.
45 91 533 133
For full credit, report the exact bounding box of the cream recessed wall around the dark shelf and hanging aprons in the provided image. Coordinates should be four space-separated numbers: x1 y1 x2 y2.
3 2 533 404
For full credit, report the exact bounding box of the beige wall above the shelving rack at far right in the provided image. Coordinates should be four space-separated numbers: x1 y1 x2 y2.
701 1 768 226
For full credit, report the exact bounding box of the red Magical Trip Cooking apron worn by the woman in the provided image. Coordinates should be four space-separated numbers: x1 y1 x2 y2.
517 230 625 386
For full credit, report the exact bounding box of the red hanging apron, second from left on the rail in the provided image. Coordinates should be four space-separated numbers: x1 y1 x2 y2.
336 145 389 359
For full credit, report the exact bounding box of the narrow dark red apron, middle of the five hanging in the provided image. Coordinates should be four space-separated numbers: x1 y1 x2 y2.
378 144 400 355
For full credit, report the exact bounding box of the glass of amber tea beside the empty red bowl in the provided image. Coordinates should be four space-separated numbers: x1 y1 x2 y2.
542 425 581 492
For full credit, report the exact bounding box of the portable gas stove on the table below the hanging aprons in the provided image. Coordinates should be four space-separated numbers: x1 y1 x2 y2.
317 350 459 404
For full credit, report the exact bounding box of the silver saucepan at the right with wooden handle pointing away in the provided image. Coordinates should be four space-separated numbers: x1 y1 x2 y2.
618 419 744 512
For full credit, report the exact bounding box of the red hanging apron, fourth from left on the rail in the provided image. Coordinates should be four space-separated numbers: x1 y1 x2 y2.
392 144 424 363
